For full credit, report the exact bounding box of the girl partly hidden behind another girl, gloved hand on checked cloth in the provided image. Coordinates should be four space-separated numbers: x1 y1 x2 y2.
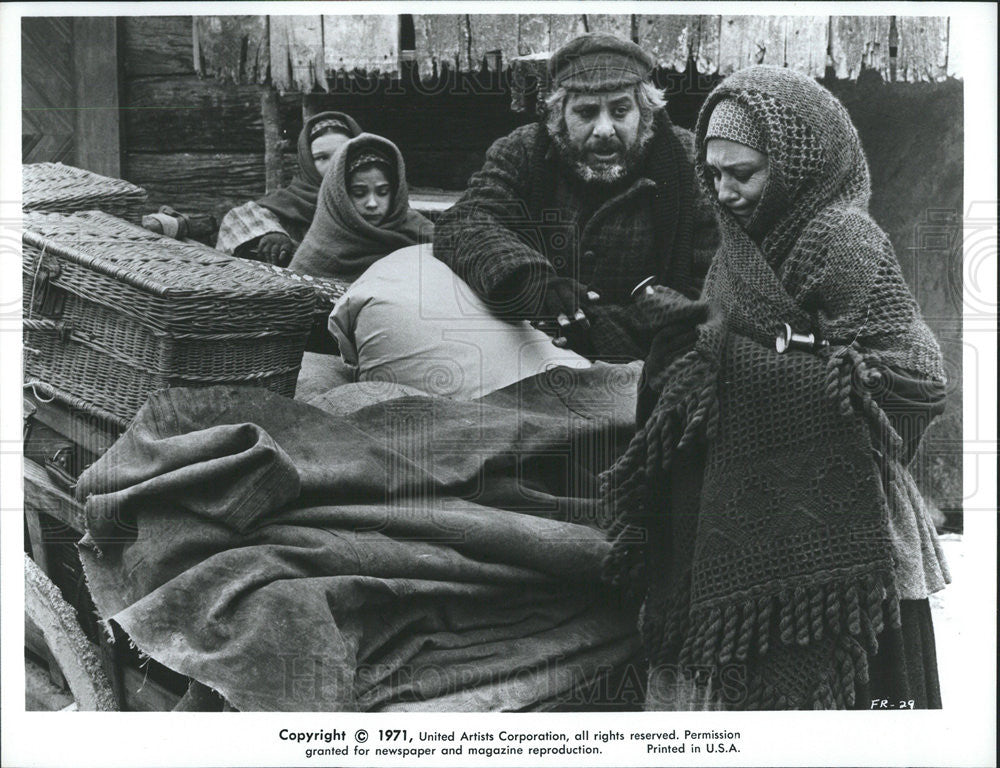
215 112 361 266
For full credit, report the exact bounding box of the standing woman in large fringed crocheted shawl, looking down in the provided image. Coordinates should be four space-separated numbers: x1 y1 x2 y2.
605 67 948 709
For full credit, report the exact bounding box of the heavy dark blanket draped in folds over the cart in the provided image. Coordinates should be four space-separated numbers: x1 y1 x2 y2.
79 365 637 711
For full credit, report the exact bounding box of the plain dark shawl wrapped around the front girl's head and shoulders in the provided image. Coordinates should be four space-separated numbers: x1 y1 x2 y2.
288 133 434 280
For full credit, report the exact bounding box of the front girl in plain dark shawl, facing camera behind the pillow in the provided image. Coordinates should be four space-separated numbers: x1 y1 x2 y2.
288 133 434 280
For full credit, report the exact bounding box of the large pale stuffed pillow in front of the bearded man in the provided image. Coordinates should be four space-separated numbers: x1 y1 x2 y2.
329 244 590 400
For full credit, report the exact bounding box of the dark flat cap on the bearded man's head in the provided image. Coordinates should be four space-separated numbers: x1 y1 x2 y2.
549 32 656 91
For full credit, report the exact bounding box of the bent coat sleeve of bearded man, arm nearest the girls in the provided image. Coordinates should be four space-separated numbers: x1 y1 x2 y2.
434 125 555 315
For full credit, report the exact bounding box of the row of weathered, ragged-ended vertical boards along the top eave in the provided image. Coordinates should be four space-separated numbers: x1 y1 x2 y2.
194 14 960 93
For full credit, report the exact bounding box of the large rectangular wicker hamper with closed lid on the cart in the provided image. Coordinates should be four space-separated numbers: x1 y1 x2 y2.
22 211 316 425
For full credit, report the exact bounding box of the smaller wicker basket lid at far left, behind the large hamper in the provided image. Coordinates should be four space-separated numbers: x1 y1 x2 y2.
21 163 146 224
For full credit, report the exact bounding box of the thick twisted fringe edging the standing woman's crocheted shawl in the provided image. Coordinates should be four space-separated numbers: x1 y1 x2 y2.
601 332 902 710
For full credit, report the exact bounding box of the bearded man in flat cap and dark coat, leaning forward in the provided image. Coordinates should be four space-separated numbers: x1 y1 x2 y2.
434 34 718 361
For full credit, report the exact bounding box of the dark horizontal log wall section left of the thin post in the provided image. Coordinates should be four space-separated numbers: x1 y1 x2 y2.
121 16 284 219
